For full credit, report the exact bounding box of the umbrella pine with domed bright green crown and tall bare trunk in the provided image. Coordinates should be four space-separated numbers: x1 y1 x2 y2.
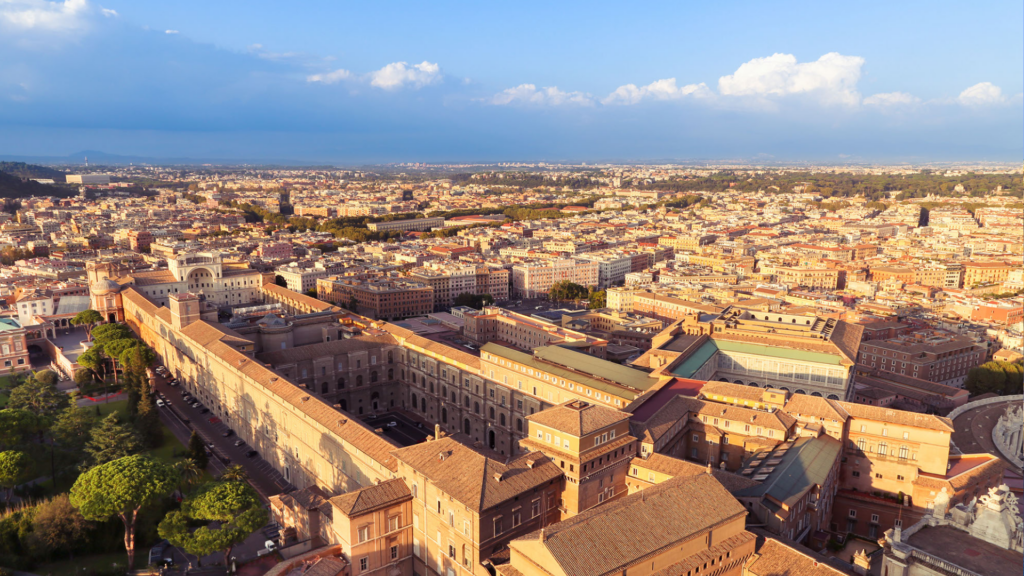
71 455 177 570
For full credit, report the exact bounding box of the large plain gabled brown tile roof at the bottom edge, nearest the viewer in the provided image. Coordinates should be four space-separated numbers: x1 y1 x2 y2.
510 474 746 576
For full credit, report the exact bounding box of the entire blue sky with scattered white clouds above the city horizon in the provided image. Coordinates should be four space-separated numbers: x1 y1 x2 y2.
0 0 1024 165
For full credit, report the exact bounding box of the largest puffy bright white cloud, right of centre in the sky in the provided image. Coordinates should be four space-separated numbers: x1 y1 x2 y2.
718 52 864 106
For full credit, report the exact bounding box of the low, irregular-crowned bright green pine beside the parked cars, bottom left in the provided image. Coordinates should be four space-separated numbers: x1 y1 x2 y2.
157 482 267 566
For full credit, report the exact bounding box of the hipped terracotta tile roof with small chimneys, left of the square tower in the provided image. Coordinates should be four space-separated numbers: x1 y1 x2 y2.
391 435 562 511
